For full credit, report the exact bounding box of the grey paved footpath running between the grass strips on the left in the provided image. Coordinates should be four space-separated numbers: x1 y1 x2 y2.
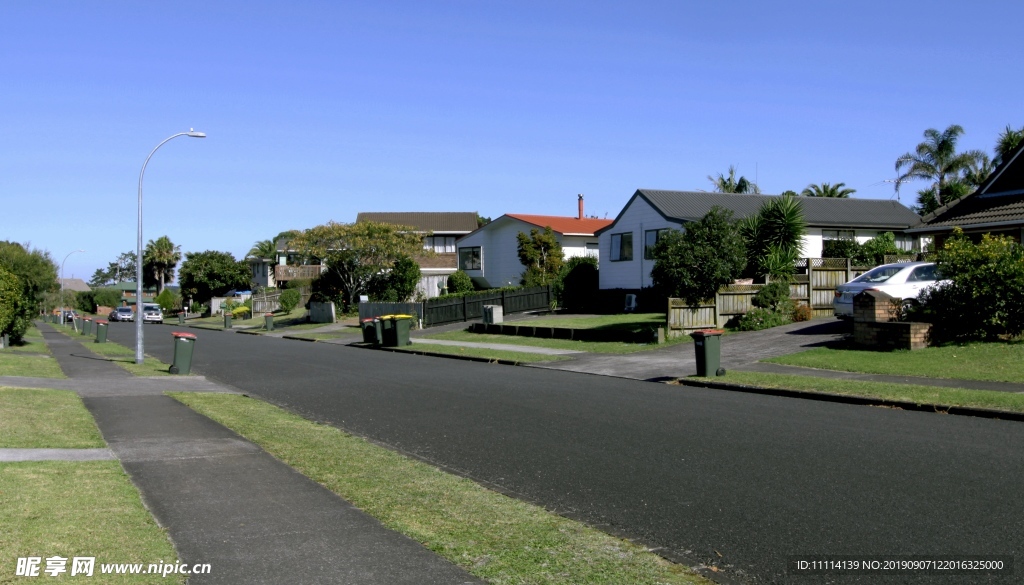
32 325 481 585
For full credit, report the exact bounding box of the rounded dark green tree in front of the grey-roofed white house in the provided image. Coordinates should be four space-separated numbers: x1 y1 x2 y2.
650 206 746 305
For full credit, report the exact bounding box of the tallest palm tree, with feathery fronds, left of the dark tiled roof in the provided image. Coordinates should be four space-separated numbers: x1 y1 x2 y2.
896 124 985 212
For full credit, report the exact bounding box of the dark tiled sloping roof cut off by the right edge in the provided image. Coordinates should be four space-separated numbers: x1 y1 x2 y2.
912 144 1024 233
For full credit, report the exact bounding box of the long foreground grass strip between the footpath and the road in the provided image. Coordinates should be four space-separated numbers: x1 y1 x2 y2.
171 392 708 585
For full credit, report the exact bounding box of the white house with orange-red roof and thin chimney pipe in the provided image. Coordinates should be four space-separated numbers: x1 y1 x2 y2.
458 196 611 287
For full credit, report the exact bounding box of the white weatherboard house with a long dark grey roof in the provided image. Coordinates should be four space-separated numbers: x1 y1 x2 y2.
598 189 921 290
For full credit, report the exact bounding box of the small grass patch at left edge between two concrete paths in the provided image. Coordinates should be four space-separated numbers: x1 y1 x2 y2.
0 386 106 449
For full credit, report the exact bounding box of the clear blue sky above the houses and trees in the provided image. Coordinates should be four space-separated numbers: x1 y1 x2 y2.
0 0 1024 280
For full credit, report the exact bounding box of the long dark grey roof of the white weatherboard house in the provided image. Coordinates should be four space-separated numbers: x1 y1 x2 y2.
634 189 921 229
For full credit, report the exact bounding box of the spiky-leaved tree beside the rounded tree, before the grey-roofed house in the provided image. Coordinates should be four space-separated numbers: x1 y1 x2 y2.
739 196 807 279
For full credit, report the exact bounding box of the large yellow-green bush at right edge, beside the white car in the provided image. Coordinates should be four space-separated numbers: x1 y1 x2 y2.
908 228 1024 342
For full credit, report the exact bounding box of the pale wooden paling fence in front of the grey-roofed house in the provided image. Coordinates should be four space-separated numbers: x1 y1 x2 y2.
668 258 870 337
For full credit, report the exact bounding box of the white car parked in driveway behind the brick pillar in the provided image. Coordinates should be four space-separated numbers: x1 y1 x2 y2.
833 262 942 320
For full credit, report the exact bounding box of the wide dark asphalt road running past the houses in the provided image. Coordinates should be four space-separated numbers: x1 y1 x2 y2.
110 324 1024 583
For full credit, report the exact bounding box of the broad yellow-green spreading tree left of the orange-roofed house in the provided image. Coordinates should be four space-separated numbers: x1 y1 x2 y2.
292 221 425 311
